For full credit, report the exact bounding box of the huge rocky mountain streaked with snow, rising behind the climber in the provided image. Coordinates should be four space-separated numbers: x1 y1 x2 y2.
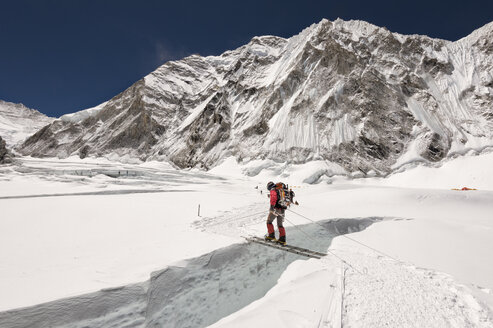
16 20 493 173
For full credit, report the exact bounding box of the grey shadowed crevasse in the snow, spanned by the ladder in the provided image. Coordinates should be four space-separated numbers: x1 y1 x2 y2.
0 220 362 328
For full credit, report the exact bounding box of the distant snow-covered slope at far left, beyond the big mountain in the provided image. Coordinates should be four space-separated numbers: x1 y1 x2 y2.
0 100 54 147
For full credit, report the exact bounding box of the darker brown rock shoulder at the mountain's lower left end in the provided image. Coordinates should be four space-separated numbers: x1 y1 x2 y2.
20 83 165 159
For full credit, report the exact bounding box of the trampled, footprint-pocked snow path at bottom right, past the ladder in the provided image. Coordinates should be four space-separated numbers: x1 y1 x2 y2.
330 244 493 328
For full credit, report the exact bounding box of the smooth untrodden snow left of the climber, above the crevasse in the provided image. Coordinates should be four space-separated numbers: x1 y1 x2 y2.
0 192 242 310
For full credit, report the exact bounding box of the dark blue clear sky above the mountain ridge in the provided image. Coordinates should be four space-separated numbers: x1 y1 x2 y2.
0 0 493 116
